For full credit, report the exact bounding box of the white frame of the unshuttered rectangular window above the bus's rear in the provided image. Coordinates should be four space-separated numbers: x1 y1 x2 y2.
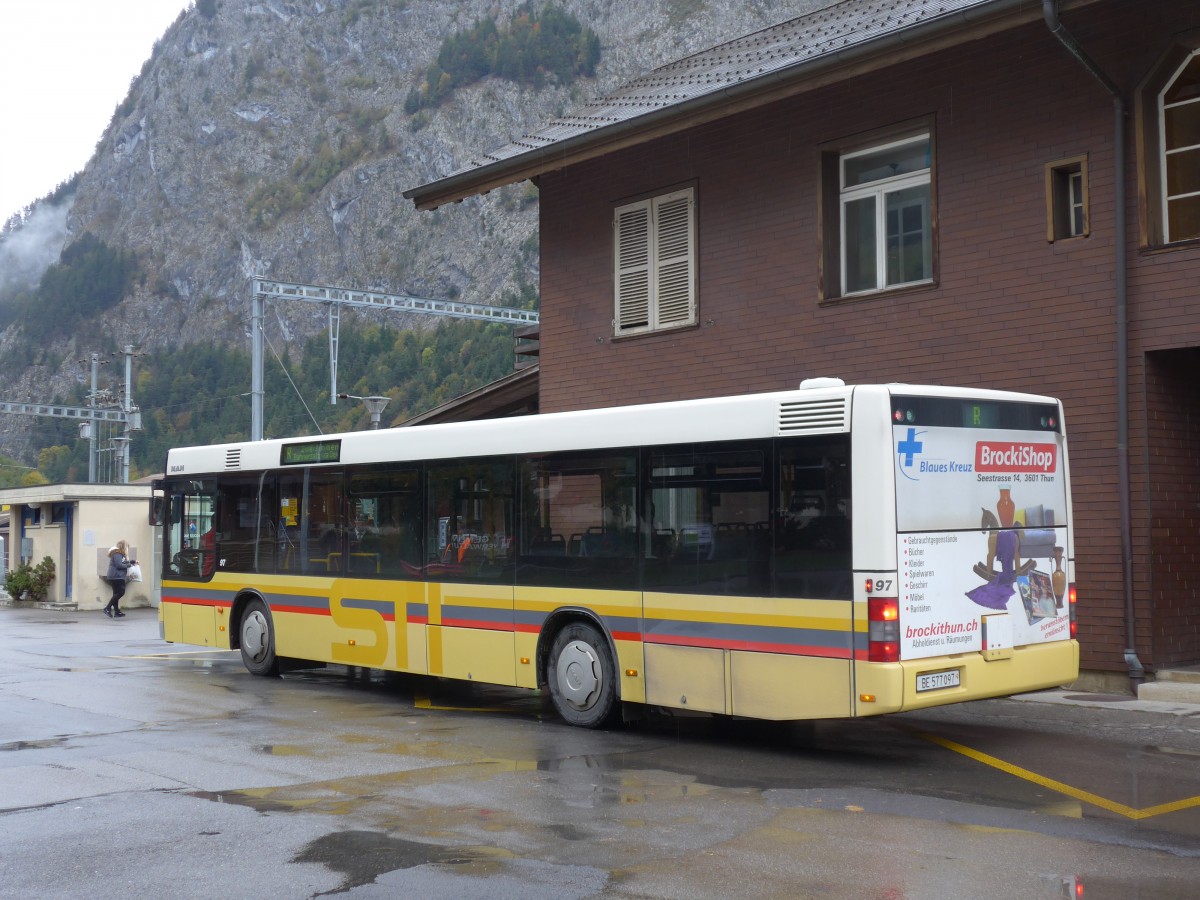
838 133 934 296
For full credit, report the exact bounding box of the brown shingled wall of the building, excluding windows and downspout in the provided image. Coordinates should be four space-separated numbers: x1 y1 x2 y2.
540 0 1200 670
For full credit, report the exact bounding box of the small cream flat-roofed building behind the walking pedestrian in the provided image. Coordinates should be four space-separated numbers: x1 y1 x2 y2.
0 480 158 610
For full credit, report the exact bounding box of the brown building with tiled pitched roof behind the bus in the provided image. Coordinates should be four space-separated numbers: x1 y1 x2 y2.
406 0 1200 680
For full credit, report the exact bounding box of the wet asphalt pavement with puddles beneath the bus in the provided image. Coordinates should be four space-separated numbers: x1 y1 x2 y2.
0 608 1200 900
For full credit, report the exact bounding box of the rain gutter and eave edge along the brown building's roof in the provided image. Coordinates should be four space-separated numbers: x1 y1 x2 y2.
403 0 1030 209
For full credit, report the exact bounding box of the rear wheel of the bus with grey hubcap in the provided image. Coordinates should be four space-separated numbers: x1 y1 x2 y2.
546 622 619 728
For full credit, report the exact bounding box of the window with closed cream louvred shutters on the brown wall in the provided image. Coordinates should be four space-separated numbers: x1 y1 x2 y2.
613 187 696 337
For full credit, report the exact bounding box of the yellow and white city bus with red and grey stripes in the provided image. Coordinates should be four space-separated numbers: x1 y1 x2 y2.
158 379 1079 727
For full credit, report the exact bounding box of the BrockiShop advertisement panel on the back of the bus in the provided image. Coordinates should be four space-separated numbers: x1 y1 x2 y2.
893 415 1070 659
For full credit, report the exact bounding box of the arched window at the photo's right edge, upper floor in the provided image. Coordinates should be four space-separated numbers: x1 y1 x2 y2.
1158 52 1200 244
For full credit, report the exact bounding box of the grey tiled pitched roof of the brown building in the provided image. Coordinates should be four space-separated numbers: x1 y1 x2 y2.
404 0 1042 209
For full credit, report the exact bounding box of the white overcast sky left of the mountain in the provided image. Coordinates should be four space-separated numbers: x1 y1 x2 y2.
0 0 191 224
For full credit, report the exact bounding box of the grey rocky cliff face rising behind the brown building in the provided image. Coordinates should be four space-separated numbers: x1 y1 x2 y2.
0 0 828 456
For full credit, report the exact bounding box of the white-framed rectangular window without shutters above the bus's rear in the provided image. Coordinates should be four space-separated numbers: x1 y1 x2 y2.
839 134 934 294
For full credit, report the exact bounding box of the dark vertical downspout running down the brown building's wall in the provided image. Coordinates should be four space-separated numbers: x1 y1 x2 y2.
1042 0 1146 694
